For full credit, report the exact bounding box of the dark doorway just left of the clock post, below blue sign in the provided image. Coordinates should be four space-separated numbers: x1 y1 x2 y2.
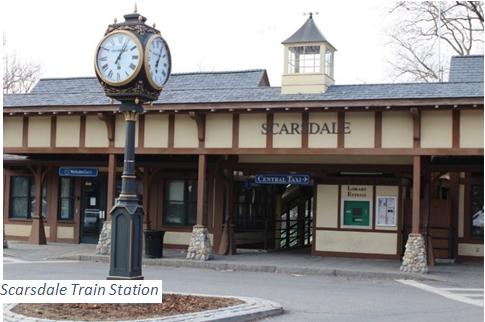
80 176 106 244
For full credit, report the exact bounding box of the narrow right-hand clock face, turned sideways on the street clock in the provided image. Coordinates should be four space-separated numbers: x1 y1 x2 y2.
145 35 171 89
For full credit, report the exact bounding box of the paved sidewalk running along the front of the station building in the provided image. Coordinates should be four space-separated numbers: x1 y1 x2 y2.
3 241 484 285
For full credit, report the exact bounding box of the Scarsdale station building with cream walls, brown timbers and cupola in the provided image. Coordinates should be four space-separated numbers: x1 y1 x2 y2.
3 16 484 266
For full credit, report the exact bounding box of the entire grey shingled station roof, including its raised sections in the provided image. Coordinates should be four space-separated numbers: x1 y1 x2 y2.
3 56 484 108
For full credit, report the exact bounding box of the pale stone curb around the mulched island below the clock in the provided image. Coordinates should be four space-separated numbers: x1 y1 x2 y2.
3 293 284 322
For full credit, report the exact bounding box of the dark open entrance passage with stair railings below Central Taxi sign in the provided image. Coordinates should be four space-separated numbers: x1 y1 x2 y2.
234 181 314 250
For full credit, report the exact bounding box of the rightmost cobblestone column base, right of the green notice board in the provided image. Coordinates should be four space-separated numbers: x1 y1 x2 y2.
401 234 428 274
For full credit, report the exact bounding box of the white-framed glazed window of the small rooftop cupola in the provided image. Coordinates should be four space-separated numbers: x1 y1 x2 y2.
288 46 320 74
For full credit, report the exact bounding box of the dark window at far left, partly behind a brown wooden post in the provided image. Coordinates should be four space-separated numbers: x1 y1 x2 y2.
9 176 47 218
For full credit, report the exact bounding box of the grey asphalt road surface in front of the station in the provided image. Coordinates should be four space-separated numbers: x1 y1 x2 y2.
3 243 483 322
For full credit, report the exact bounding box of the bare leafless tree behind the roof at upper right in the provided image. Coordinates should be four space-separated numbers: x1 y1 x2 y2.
389 1 484 82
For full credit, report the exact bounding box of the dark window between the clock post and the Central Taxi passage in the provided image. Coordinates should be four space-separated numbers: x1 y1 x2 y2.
164 179 197 226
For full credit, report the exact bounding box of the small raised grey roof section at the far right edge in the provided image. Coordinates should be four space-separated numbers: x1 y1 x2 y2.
448 55 483 83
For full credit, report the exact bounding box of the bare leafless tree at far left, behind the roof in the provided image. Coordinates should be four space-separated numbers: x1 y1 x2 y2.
3 35 40 94
